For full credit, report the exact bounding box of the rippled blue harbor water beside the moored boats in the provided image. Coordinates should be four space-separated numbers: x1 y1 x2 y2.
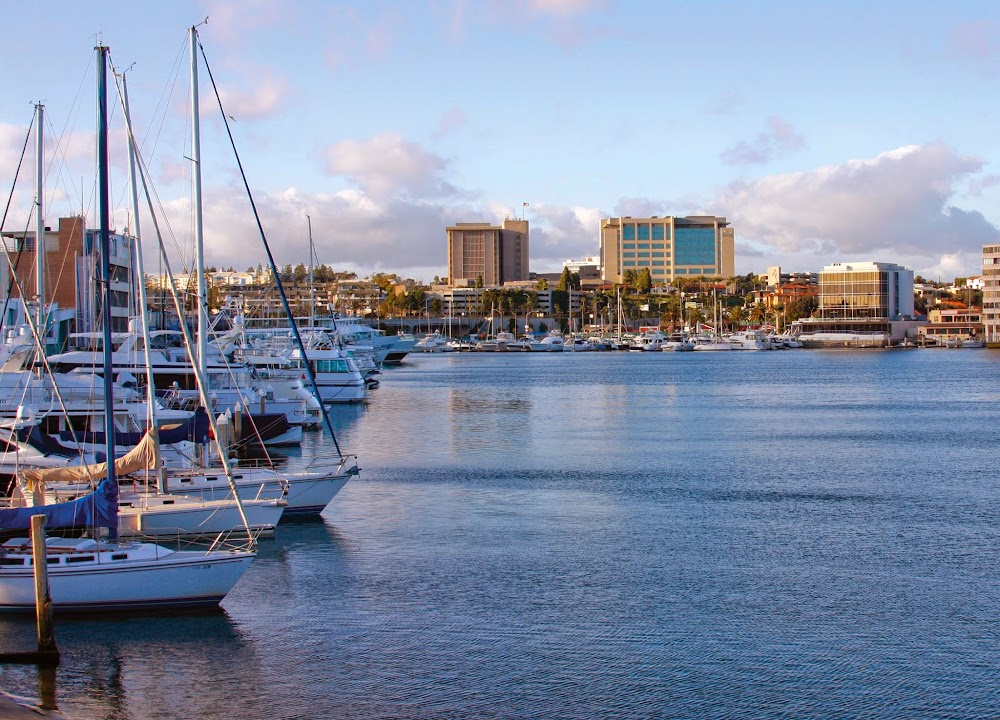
0 350 1000 719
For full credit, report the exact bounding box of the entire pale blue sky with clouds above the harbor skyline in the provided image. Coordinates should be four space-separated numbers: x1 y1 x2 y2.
0 0 1000 280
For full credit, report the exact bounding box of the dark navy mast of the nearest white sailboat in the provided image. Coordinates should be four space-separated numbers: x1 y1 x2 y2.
96 45 118 540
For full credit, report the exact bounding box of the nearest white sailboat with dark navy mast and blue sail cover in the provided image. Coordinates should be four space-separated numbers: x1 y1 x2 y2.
0 40 257 612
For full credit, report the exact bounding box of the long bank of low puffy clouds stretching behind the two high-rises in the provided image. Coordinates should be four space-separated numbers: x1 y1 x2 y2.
150 135 1000 279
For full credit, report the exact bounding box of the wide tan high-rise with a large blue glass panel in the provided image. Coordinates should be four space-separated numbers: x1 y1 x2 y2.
600 215 736 283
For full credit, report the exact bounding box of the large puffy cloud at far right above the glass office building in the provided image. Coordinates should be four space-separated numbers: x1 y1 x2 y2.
711 143 1000 273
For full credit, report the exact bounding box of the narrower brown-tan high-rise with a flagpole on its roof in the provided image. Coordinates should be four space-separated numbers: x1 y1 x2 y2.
447 219 528 287
